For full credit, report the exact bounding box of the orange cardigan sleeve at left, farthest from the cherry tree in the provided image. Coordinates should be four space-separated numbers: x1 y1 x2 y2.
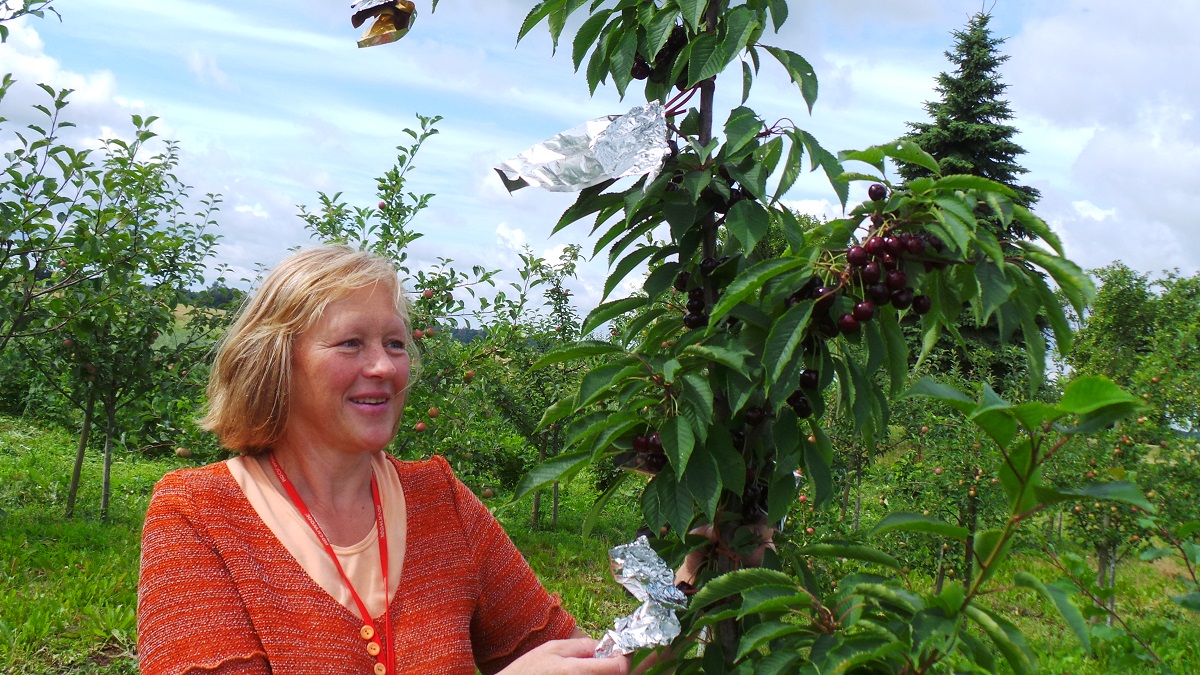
138 472 270 675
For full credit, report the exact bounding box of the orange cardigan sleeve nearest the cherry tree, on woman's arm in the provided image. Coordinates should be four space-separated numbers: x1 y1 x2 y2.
436 458 575 674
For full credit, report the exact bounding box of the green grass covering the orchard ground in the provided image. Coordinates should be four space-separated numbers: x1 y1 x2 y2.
0 417 1200 675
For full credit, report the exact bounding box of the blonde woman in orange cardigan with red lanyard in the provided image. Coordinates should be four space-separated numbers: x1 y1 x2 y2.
138 246 628 675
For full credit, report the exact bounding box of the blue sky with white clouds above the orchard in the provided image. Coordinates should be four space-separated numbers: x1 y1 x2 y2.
0 0 1200 311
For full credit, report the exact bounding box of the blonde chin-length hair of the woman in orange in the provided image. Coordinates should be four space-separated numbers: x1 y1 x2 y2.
200 246 418 455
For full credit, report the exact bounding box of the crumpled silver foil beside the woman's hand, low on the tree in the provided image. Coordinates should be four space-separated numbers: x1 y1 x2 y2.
595 536 688 658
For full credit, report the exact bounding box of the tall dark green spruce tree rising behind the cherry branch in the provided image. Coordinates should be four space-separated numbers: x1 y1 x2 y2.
898 12 1040 238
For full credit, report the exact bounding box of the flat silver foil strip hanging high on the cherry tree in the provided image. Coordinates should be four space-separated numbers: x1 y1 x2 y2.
496 101 670 192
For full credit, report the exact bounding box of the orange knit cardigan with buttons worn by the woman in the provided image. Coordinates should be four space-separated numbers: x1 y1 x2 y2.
138 458 575 675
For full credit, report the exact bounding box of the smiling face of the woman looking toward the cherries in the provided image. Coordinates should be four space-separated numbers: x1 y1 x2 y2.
276 286 409 454
